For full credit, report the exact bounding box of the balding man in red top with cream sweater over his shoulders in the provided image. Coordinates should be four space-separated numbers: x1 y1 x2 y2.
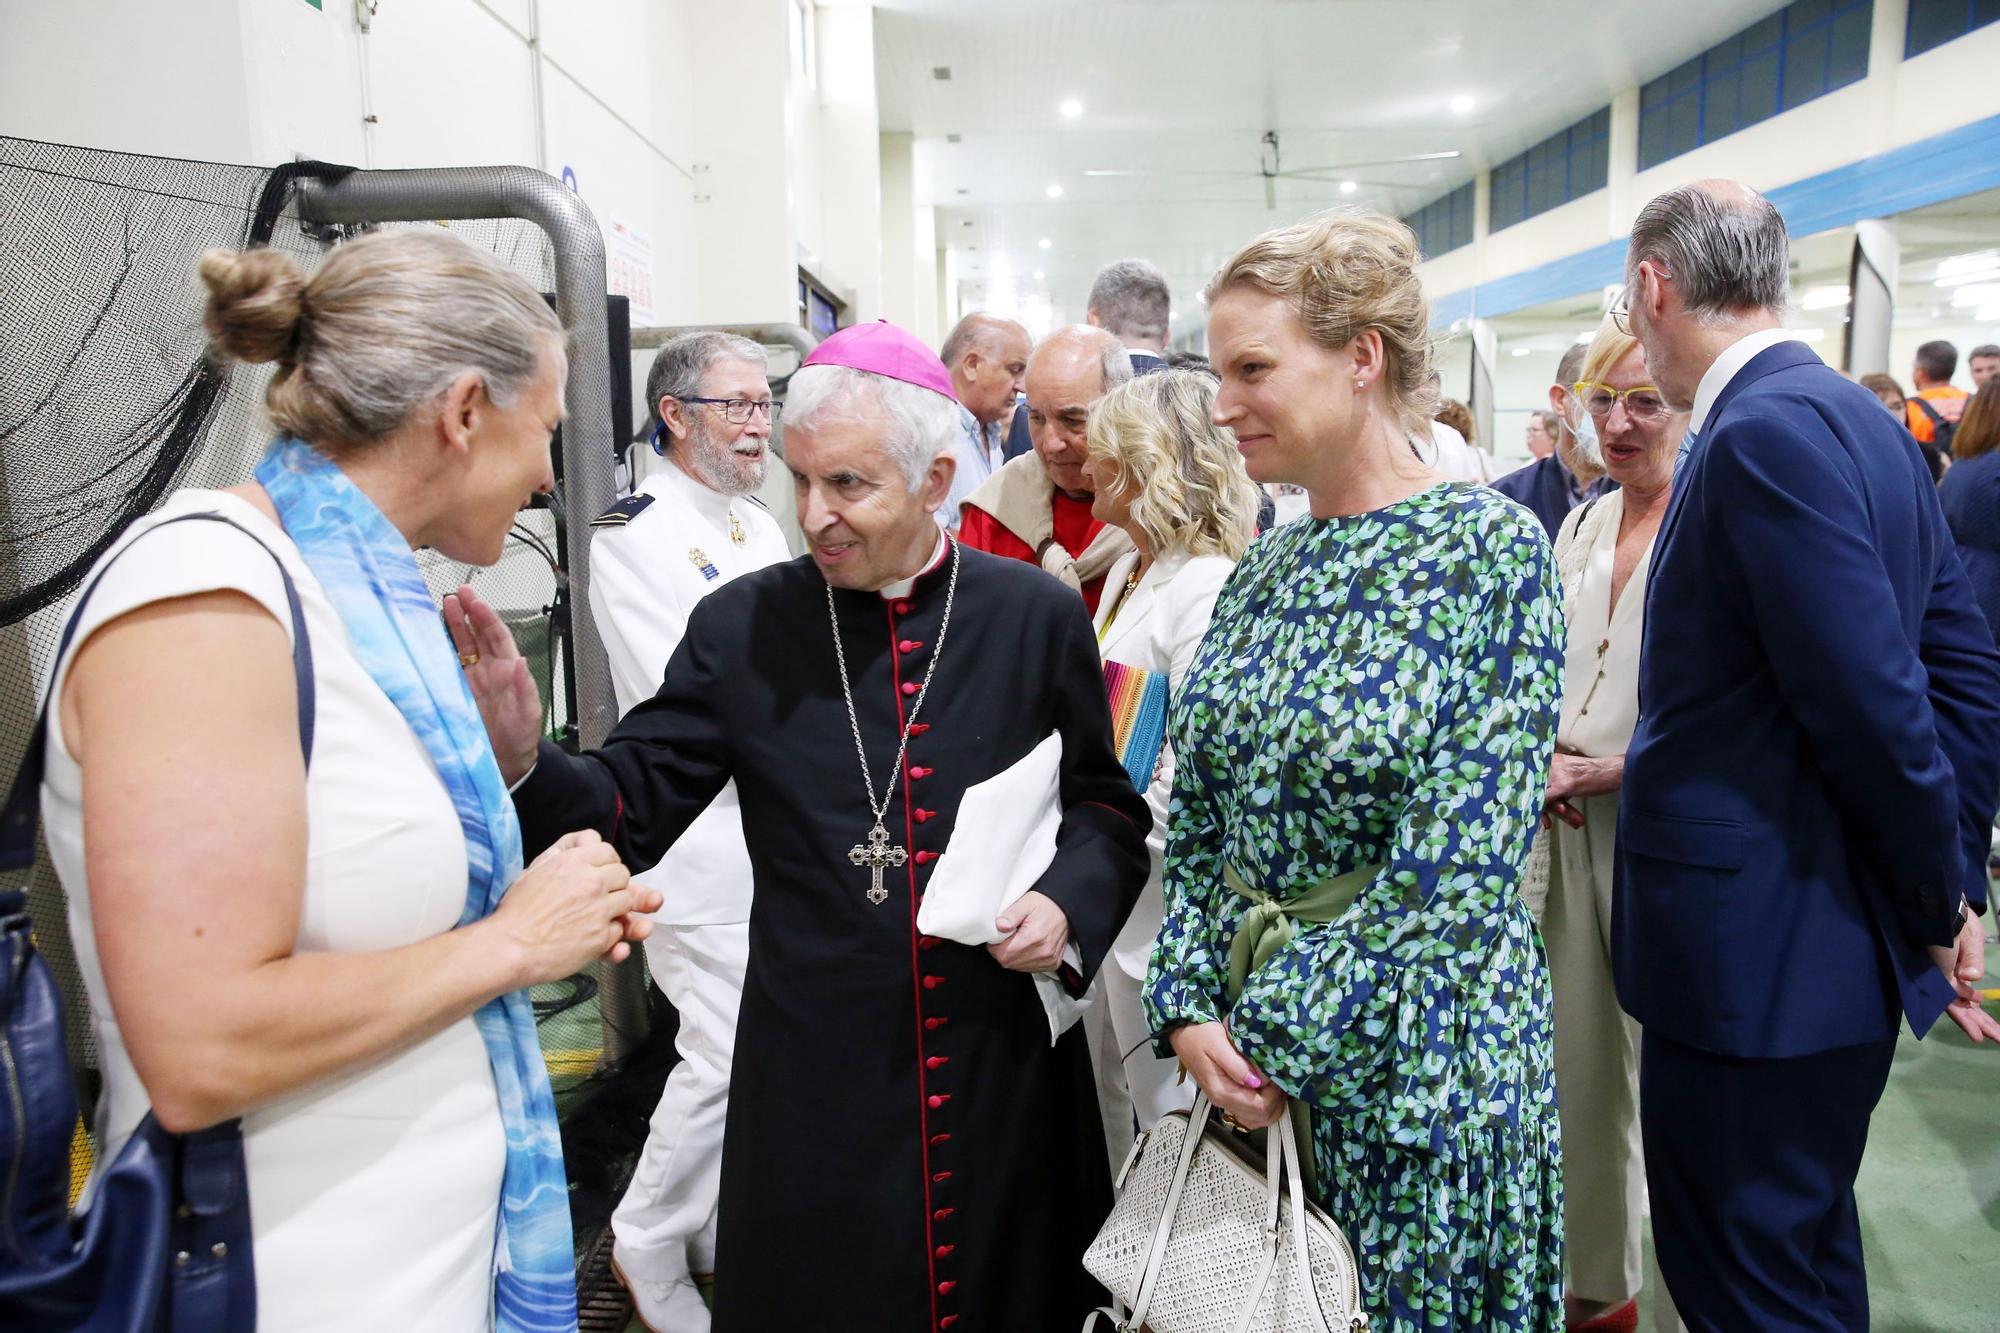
958 324 1132 612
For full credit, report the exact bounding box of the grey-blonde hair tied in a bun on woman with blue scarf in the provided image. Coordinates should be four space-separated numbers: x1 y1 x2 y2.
198 228 562 452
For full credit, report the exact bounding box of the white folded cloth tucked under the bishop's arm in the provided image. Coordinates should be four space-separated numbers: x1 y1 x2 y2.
916 731 1096 1045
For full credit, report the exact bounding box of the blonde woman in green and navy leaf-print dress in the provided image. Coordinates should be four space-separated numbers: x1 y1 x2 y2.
1146 214 1562 1333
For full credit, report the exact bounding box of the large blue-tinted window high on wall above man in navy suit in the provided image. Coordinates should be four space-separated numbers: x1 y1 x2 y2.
1638 0 1872 170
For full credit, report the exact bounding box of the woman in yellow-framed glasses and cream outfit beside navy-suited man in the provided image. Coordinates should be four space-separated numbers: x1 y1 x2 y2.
1530 320 1688 1333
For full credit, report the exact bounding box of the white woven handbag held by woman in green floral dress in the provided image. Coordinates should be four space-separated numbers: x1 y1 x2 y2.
1084 1095 1368 1333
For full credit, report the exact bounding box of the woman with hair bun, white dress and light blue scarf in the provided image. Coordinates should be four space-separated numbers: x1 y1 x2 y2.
42 230 658 1331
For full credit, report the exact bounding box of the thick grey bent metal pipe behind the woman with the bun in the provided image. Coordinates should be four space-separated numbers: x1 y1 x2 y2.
296 166 618 747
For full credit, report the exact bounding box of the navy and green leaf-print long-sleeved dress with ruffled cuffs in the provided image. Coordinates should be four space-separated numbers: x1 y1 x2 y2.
1146 482 1564 1333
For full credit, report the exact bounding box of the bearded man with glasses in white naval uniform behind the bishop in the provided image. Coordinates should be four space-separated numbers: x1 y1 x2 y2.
590 332 792 1333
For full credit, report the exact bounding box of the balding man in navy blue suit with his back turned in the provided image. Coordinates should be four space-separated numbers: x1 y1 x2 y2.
1612 182 2000 1333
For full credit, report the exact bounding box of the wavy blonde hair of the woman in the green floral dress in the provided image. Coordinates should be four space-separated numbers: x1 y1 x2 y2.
1204 208 1438 440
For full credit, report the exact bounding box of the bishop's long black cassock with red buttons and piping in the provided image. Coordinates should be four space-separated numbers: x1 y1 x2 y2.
460 326 1148 1333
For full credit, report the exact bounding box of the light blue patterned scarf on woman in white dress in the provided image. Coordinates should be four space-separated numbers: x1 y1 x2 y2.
256 438 576 1333
